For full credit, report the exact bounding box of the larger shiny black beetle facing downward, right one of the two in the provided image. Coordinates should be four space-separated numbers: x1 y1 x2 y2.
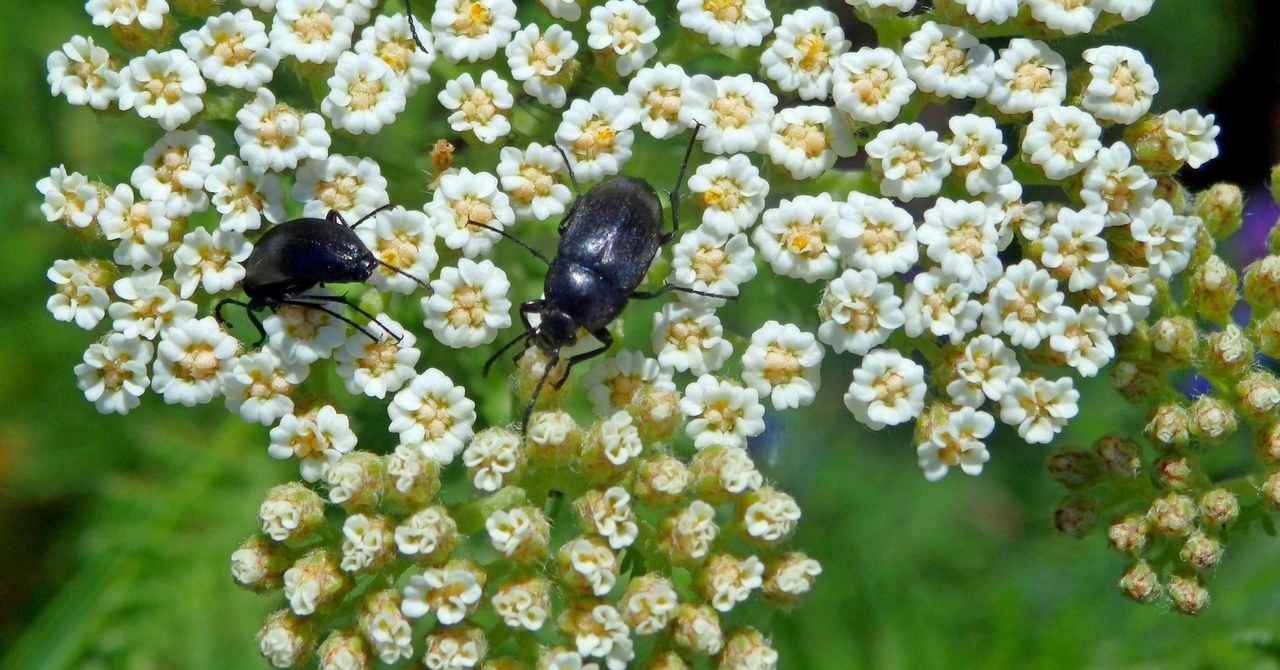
470 124 736 428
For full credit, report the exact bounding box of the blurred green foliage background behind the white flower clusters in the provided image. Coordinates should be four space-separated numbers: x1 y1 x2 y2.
0 0 1280 670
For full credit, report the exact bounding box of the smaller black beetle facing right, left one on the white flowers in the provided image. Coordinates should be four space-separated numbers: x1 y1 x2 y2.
214 205 430 347
